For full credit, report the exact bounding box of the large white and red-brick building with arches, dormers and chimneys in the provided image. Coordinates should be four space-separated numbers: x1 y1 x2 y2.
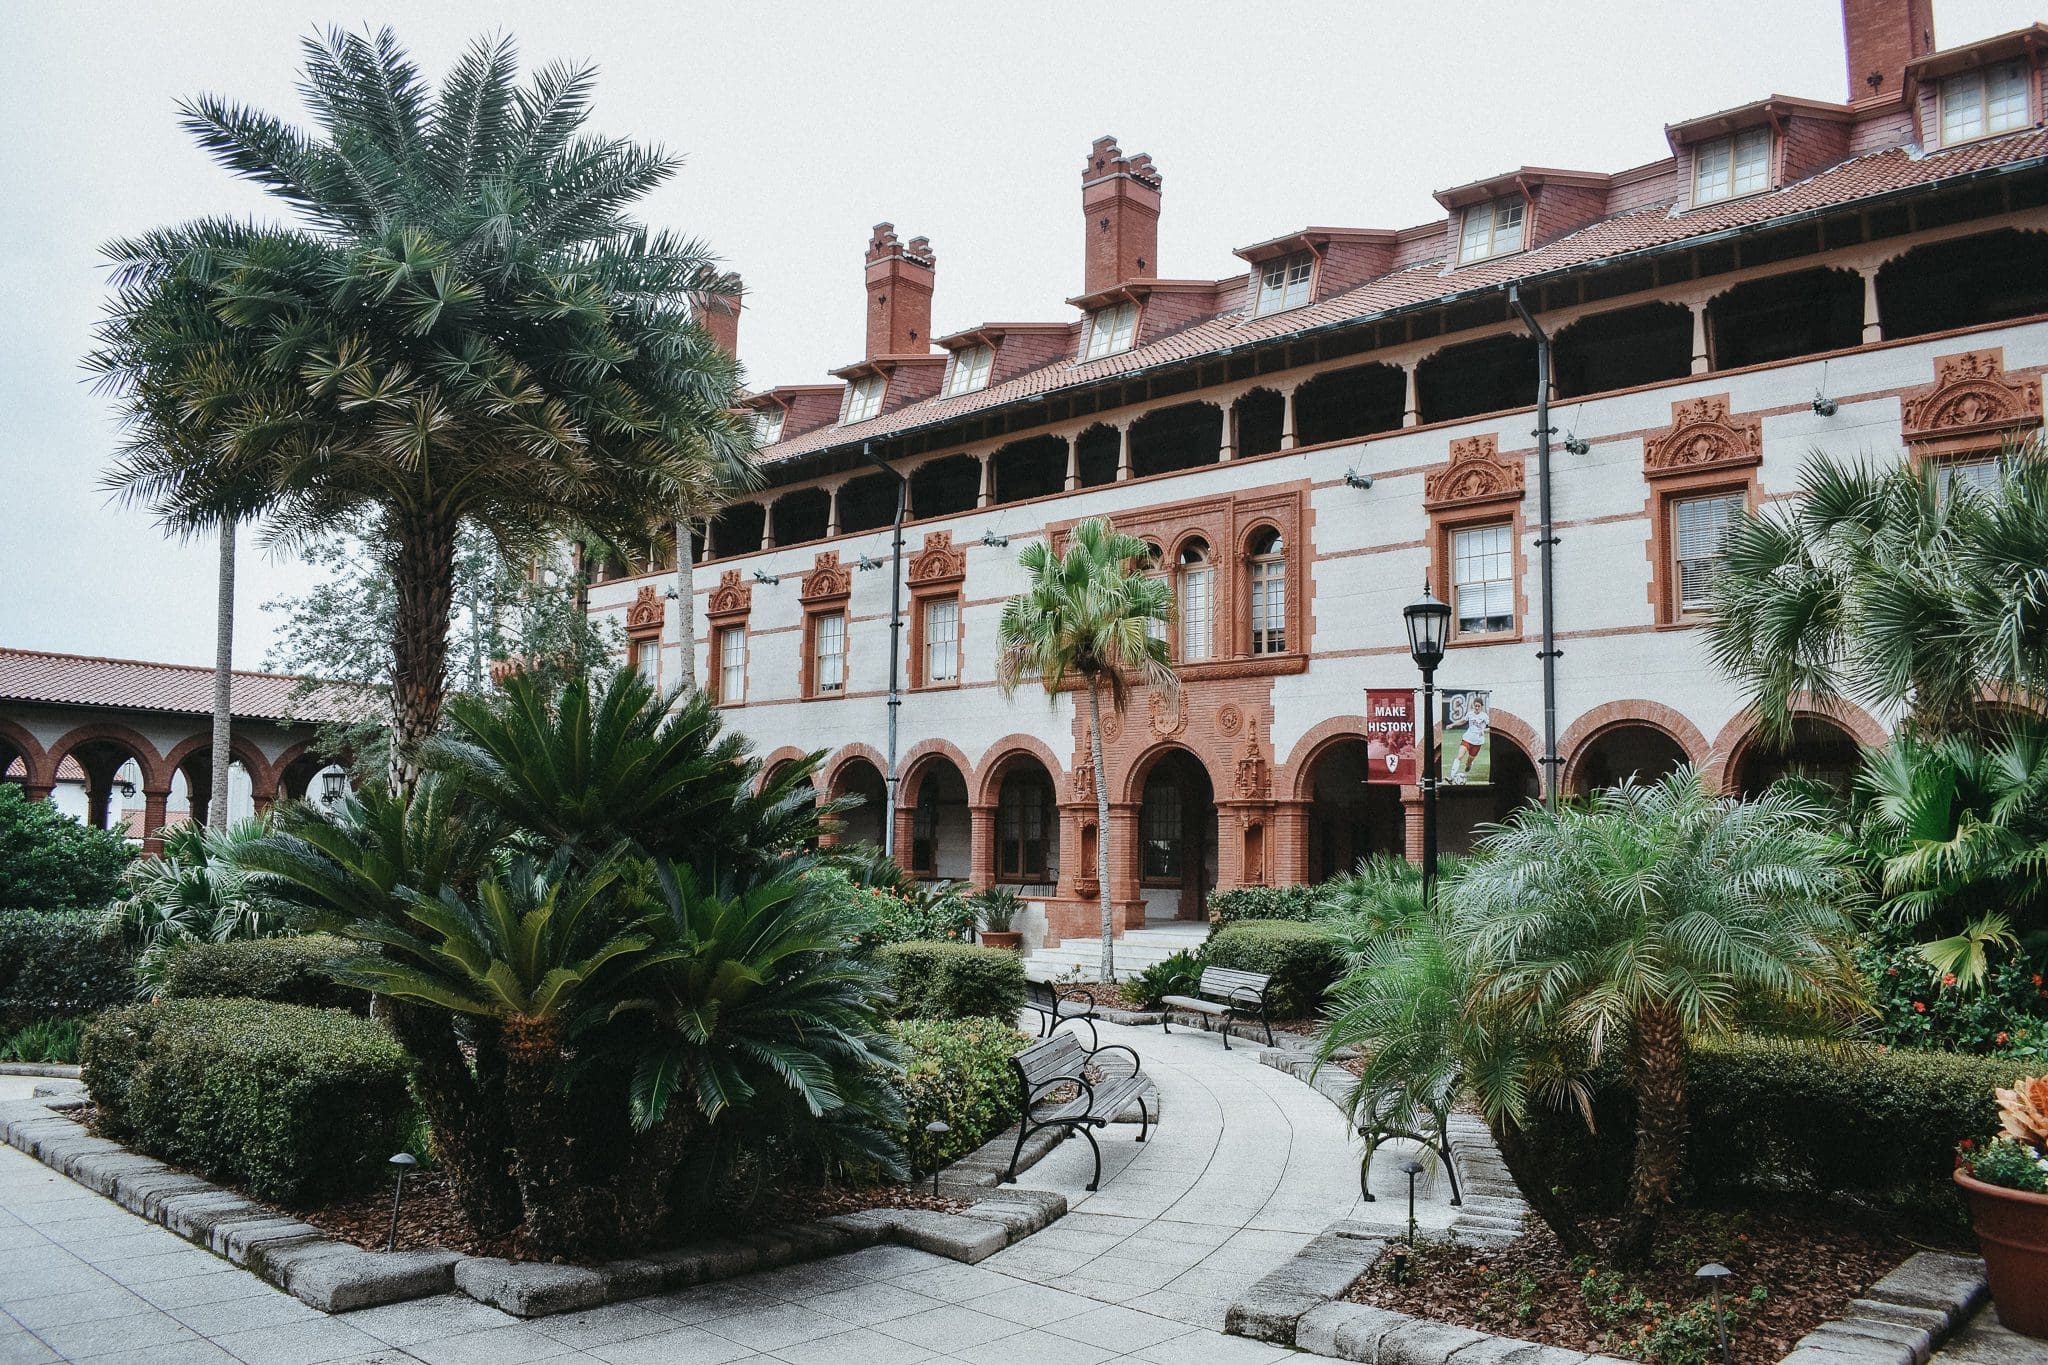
590 0 2048 957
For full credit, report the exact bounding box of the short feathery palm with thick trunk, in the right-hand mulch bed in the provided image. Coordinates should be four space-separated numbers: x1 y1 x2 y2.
1448 767 1862 1265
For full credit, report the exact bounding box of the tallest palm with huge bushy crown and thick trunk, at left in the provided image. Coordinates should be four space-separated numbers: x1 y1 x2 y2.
109 29 752 786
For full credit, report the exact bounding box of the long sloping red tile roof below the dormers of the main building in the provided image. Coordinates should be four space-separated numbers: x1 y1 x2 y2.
760 129 2048 465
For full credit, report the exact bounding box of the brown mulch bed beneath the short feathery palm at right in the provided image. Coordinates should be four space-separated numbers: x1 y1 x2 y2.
1346 1209 1952 1365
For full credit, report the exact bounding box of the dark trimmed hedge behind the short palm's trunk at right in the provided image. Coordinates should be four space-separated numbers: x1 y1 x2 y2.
1532 1038 2028 1220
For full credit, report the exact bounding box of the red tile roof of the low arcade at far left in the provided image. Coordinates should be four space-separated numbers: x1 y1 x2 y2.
0 649 352 720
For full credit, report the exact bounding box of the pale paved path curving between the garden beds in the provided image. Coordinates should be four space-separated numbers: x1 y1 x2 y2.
0 1025 1450 1365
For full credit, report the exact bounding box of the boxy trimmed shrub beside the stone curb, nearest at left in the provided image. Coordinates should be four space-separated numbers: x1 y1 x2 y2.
82 999 414 1207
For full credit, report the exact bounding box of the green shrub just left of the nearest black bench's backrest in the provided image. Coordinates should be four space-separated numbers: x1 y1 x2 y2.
889 1019 1030 1171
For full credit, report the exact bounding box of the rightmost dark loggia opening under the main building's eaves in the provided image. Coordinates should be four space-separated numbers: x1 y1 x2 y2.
1878 229 2048 340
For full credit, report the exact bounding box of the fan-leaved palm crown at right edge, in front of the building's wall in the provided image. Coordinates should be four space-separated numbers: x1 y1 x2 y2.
1708 438 2048 739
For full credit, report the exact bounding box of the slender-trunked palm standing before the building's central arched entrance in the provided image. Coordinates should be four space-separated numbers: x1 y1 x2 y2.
995 518 1180 980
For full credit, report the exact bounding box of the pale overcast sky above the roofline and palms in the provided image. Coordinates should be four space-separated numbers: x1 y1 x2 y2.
0 0 2040 667
